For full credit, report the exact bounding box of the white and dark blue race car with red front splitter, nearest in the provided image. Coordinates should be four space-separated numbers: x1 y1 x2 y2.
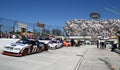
2 39 48 56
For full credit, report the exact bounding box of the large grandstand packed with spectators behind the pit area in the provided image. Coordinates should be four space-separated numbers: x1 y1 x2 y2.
64 19 120 36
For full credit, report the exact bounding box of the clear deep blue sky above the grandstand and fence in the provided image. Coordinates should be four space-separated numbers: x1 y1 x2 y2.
0 0 120 26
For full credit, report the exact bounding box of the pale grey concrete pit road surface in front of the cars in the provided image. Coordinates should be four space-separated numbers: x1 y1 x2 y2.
0 45 120 70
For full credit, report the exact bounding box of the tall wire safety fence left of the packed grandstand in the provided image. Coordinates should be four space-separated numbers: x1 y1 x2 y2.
0 17 65 36
